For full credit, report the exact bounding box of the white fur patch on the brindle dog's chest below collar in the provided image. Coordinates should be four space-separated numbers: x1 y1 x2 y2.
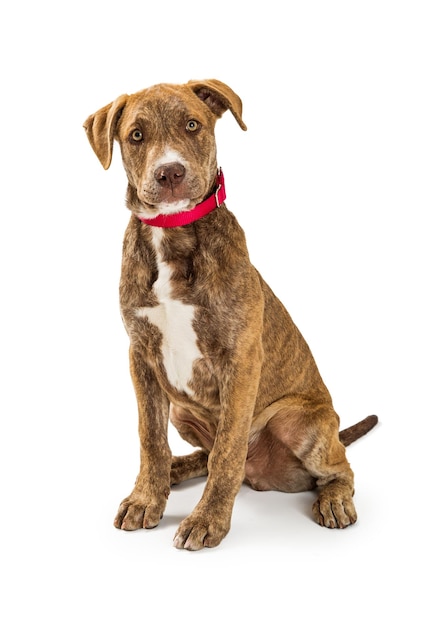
135 228 202 393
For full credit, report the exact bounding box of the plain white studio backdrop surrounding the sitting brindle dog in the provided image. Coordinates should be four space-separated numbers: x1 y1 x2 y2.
0 0 447 626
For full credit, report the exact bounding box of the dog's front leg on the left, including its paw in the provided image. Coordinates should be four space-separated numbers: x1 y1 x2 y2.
114 348 171 530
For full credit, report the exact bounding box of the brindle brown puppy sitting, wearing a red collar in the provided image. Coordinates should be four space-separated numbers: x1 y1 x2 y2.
84 79 378 550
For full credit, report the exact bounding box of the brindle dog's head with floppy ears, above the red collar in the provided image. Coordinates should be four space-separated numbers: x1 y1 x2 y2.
84 79 246 218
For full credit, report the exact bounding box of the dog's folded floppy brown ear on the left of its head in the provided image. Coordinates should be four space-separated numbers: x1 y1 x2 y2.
84 95 129 170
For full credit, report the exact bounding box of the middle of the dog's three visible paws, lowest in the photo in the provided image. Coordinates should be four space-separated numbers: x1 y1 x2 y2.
174 514 230 550
